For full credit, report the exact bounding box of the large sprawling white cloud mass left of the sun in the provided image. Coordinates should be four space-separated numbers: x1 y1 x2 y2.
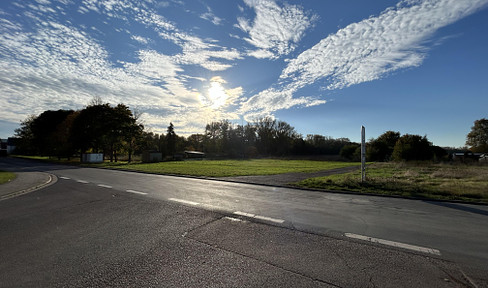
0 0 242 134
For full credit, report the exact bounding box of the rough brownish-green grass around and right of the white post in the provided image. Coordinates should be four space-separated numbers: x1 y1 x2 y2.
294 163 488 203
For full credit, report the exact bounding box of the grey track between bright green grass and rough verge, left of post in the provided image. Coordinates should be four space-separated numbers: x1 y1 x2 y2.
220 166 360 186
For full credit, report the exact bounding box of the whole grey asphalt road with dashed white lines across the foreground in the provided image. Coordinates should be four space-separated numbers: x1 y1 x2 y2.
0 160 488 287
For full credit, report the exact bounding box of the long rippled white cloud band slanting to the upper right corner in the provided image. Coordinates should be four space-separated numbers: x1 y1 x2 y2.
280 0 487 89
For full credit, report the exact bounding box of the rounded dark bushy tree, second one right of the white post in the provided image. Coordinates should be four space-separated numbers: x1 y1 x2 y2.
392 134 433 161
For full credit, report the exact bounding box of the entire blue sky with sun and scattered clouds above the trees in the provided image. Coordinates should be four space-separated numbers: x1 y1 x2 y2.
0 0 488 147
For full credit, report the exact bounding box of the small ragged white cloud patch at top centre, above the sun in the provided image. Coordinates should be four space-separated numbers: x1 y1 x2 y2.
235 0 317 59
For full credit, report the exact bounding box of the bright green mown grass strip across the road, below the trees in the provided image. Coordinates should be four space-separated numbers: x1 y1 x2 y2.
90 159 354 177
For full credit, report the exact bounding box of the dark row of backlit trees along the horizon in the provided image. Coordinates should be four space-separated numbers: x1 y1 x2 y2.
16 98 488 162
